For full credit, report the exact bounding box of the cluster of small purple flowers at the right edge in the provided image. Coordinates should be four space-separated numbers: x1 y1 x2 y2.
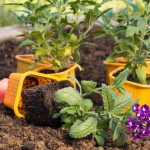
127 104 150 140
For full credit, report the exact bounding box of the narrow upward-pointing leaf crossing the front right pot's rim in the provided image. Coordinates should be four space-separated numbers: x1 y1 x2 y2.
113 68 130 87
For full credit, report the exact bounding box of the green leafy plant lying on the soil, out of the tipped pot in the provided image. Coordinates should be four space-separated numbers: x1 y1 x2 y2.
53 69 132 145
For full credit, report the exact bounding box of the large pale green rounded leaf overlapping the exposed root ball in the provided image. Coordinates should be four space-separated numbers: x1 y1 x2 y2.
55 87 82 106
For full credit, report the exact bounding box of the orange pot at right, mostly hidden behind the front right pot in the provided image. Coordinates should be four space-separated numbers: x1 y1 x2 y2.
103 57 150 83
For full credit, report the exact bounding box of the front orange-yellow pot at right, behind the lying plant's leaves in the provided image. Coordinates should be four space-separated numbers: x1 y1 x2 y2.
109 67 150 106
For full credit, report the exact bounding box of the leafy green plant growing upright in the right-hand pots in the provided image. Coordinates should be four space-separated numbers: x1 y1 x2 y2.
99 0 150 84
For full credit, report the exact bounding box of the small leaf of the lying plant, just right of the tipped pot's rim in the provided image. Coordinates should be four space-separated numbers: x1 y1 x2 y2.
81 80 97 93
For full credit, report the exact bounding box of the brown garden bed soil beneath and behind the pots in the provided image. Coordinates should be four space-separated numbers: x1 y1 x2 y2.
0 39 150 150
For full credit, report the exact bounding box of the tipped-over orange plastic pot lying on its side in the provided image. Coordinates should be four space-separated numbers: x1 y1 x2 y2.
4 64 80 118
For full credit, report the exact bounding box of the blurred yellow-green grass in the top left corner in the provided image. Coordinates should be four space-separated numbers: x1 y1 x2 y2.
0 0 26 27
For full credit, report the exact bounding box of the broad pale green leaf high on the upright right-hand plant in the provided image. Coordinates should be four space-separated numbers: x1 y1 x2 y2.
126 26 140 37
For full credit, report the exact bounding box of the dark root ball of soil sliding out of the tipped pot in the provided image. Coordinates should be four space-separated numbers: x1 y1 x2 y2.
22 81 72 127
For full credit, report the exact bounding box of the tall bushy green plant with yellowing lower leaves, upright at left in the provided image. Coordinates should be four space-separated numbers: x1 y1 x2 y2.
14 0 107 70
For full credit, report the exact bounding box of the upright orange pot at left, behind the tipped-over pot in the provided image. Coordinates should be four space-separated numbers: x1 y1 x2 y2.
15 54 52 73
